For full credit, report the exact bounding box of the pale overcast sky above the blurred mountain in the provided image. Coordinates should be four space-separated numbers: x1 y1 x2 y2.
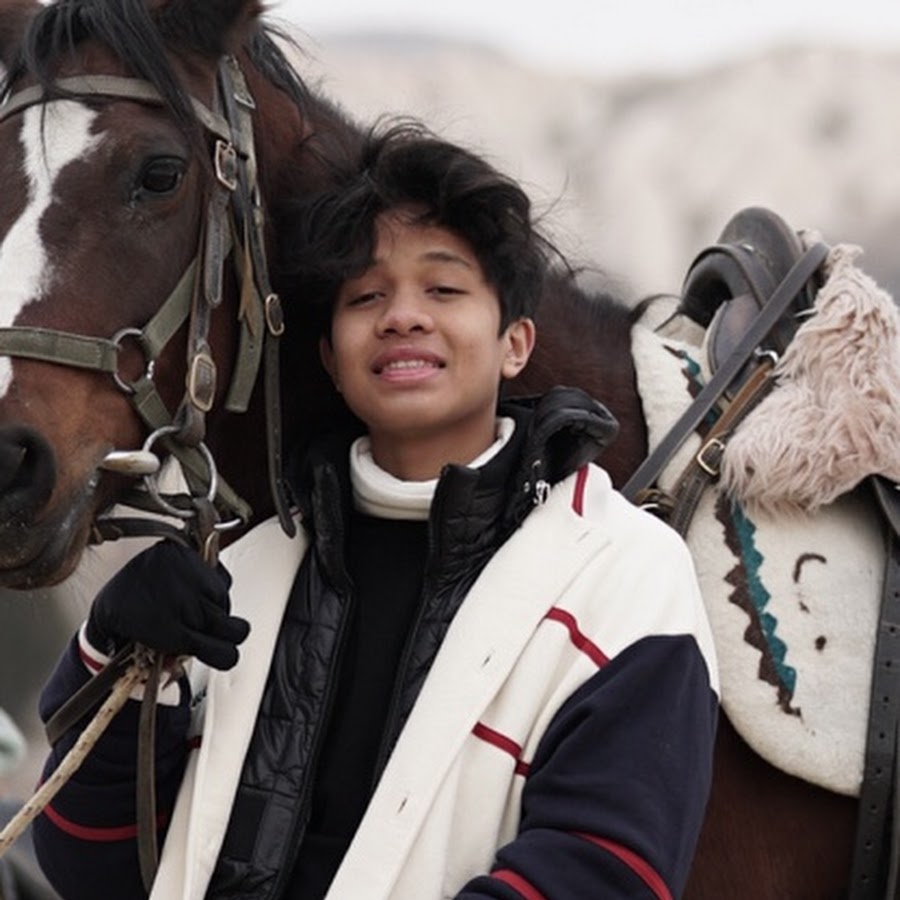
269 0 900 72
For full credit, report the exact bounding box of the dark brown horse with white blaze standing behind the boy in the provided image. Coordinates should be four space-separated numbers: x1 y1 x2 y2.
0 0 880 900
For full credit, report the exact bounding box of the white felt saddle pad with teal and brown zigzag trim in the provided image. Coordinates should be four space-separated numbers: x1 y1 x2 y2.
632 316 884 796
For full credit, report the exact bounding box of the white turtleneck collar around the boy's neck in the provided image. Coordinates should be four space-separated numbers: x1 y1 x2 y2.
350 416 516 521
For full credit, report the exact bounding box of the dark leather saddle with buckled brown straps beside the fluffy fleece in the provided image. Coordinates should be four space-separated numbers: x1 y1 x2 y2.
622 207 829 535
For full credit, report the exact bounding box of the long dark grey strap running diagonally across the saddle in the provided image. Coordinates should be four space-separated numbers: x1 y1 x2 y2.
622 243 829 501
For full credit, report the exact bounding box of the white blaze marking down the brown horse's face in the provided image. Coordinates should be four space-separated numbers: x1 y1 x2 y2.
0 100 100 397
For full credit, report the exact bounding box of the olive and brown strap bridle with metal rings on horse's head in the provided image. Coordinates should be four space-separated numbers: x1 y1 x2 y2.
0 56 295 541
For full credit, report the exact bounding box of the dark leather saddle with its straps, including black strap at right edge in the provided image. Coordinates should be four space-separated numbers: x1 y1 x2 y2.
622 207 900 900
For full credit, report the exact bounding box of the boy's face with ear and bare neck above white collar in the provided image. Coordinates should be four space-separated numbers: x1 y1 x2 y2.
321 213 534 480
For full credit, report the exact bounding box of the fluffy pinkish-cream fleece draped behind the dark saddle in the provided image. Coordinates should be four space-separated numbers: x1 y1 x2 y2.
722 245 900 513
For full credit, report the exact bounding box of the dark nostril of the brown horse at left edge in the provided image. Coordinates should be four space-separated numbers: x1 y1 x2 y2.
0 426 56 515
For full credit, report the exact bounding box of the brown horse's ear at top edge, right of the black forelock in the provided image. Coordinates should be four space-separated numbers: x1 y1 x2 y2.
149 0 264 59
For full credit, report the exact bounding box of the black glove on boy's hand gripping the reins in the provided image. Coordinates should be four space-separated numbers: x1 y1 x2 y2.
87 541 250 669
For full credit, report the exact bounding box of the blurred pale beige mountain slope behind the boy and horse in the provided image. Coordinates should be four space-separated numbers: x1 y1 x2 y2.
292 34 900 294
